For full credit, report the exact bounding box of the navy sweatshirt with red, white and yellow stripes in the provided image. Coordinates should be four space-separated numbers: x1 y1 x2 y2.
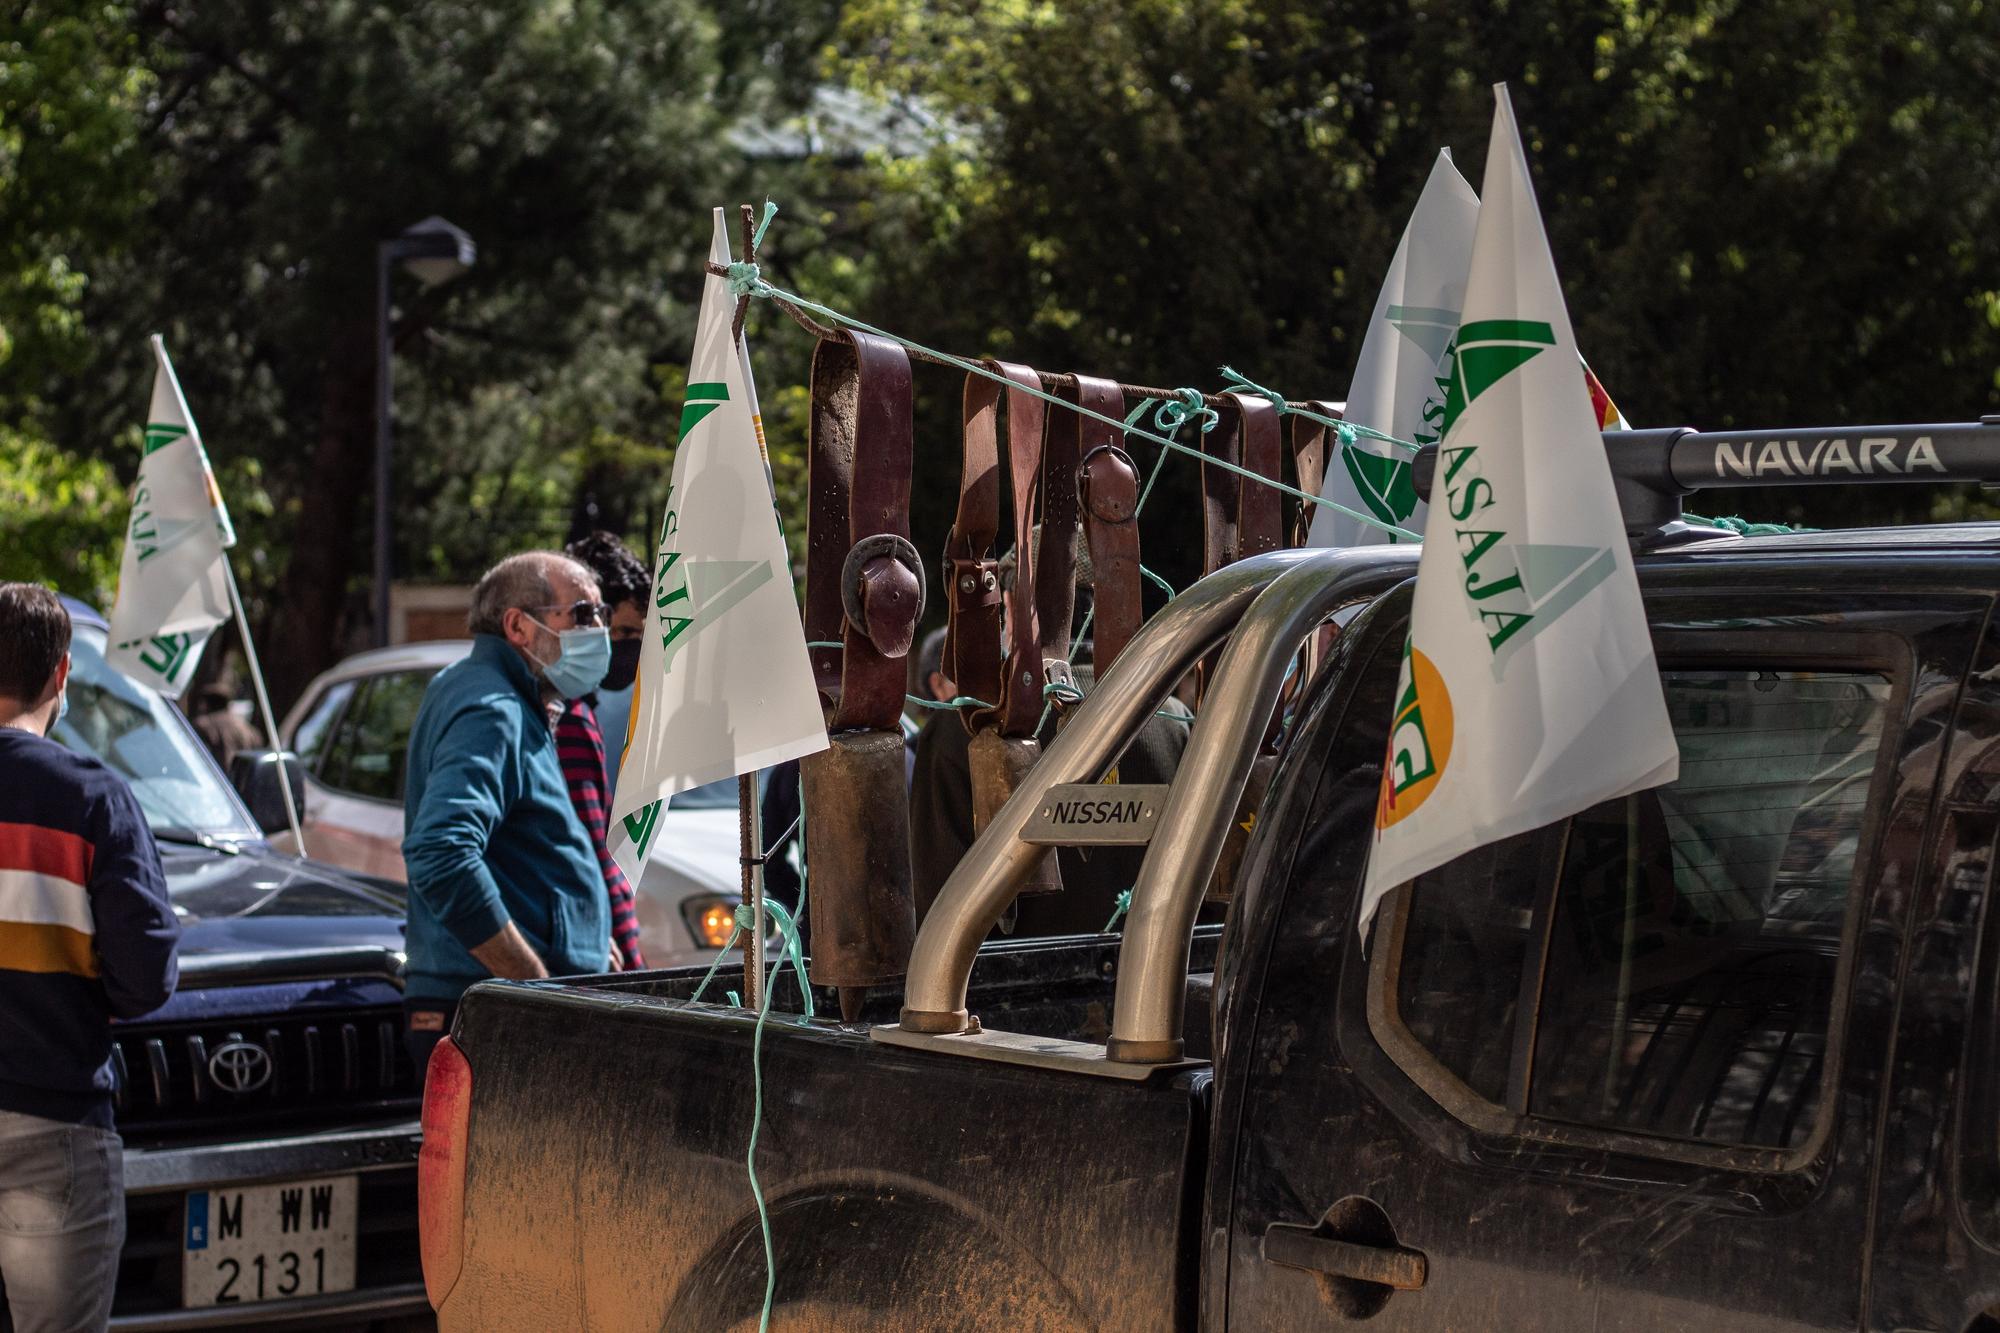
0 727 180 1129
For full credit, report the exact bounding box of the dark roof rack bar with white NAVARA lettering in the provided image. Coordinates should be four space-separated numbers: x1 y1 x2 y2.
1414 416 2000 548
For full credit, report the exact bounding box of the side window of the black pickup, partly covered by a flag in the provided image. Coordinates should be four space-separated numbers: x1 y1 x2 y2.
1376 669 1892 1151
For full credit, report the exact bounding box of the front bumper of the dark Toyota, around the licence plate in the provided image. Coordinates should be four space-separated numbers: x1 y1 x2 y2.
110 1121 430 1333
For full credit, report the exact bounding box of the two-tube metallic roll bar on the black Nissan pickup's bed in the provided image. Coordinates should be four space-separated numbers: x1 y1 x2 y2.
898 546 1416 1065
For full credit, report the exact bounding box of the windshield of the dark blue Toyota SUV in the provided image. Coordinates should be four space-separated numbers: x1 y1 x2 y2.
50 624 258 837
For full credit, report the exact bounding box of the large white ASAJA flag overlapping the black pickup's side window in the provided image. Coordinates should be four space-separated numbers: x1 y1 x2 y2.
1362 86 1680 929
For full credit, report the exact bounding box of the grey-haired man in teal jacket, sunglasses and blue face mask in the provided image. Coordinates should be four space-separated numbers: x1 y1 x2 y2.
402 550 612 1069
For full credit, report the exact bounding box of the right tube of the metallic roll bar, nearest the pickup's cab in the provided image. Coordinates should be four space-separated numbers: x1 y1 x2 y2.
1104 546 1418 1063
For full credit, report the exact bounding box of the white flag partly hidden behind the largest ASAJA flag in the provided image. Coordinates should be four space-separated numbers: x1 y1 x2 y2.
1306 150 1480 546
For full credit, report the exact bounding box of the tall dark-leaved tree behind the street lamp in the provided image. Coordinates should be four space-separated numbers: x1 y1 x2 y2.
35 0 836 699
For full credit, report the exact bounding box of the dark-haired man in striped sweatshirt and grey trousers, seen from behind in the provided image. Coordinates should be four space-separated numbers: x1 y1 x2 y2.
0 582 180 1333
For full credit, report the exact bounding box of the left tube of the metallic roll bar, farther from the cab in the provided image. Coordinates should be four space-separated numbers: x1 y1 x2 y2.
902 548 1320 1033
